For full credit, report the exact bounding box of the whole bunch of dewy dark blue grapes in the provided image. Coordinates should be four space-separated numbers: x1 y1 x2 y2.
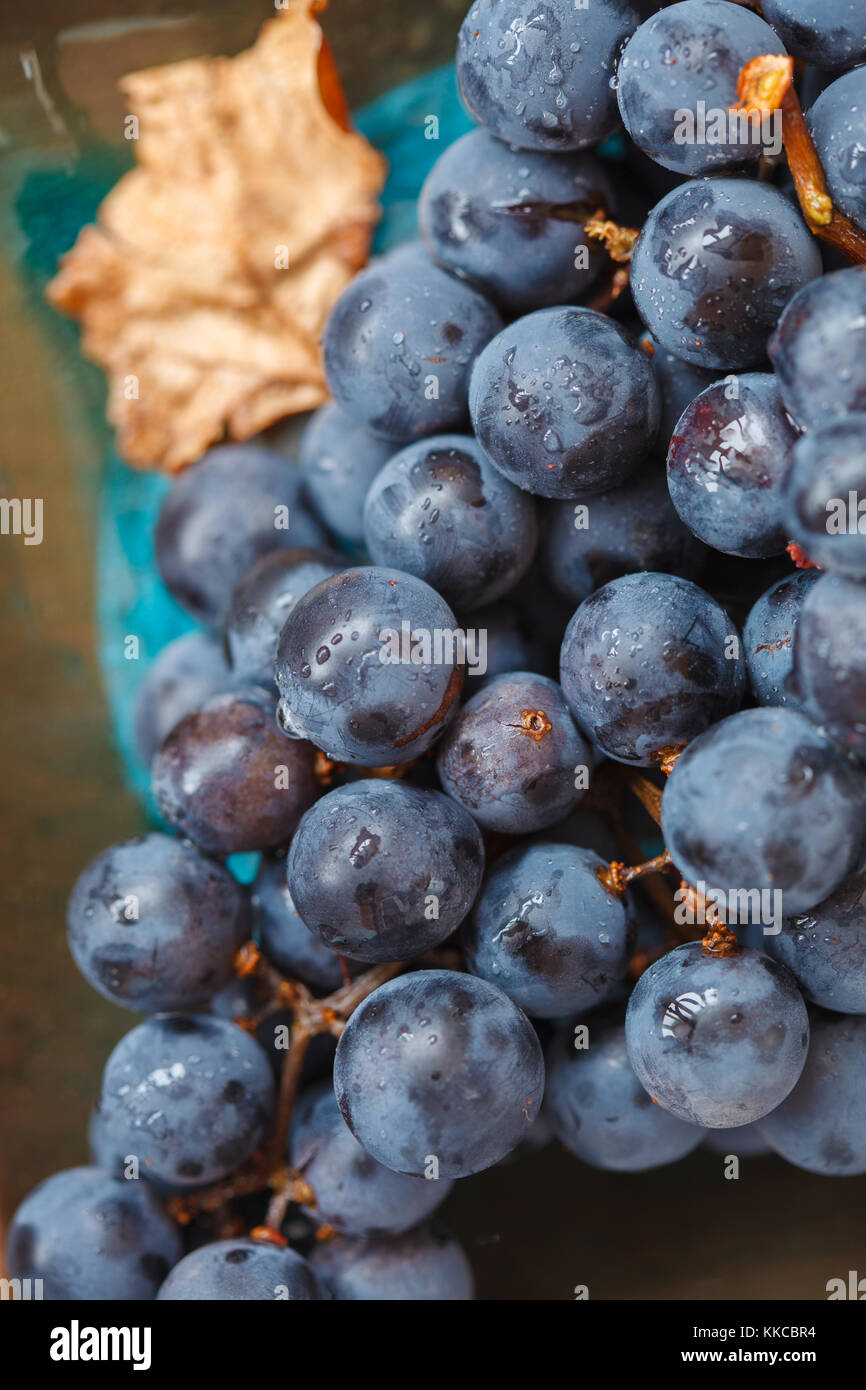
8 0 866 1300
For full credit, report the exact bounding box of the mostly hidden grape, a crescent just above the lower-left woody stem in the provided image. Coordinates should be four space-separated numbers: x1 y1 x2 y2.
250 856 360 994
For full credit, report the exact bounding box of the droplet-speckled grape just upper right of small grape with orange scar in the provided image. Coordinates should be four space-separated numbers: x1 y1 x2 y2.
560 573 745 767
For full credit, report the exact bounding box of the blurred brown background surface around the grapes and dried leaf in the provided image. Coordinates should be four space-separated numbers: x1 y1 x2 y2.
0 0 866 1300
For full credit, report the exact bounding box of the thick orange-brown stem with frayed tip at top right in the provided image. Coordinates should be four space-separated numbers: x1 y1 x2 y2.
731 53 866 264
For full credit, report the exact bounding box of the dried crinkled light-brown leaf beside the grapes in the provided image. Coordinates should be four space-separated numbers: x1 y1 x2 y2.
47 0 385 471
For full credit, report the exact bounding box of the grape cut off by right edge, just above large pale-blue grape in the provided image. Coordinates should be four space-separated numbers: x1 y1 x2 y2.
792 574 866 760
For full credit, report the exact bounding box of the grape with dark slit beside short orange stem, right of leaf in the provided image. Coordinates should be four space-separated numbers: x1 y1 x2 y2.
418 129 614 316
